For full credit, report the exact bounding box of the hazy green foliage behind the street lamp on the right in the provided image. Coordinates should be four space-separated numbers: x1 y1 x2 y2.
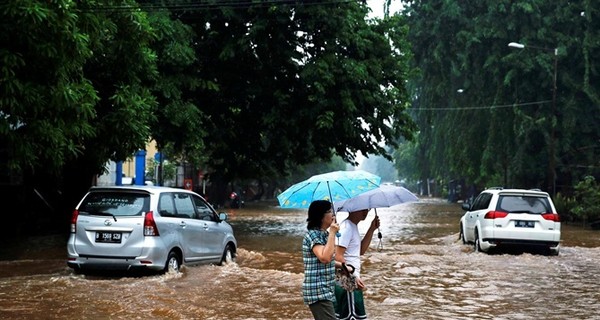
404 0 600 191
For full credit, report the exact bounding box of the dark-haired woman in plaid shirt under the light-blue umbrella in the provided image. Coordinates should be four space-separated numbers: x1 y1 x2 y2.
302 200 341 320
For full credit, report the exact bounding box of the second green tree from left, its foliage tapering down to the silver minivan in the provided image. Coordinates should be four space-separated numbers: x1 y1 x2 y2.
58 1 159 211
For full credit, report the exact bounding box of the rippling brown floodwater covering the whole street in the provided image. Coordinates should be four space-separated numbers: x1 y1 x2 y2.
0 199 600 320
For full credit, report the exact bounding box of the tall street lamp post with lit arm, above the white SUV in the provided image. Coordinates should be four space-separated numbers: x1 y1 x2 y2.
508 42 558 196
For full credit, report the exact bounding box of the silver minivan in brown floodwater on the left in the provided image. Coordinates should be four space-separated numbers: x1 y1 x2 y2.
67 185 237 272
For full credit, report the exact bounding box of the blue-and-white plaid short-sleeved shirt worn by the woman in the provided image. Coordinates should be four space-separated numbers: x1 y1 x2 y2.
302 230 335 305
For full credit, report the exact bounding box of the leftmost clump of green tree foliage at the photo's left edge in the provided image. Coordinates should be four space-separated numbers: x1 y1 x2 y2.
0 0 99 172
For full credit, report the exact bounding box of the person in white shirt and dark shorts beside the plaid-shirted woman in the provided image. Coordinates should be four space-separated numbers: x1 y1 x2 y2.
335 209 379 319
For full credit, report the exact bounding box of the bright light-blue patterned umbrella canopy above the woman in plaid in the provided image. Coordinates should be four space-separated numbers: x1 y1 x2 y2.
277 170 381 208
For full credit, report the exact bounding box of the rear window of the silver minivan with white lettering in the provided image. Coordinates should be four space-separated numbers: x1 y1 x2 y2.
79 192 150 216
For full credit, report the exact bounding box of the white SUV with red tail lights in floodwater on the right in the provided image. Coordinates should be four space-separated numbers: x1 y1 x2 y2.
460 188 560 255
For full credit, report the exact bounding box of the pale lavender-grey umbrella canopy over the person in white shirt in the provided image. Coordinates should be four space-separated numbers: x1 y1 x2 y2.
335 185 419 212
